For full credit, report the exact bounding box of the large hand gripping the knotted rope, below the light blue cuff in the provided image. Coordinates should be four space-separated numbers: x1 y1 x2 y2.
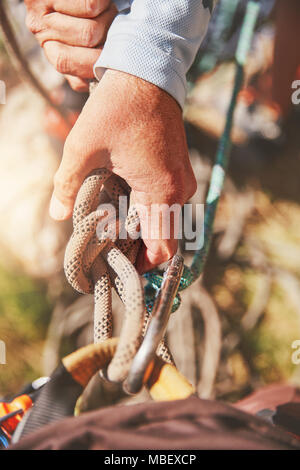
50 70 196 272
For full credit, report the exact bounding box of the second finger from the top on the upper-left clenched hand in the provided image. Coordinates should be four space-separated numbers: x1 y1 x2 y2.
34 8 116 48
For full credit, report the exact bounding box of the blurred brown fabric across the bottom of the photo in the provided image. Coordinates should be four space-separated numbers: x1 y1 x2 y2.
11 396 300 450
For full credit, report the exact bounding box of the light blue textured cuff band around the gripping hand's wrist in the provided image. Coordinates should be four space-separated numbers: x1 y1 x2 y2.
94 34 186 108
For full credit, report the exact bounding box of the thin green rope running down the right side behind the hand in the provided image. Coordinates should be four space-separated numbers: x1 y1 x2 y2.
145 0 260 312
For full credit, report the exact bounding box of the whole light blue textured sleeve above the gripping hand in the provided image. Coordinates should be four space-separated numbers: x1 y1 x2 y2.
94 0 214 107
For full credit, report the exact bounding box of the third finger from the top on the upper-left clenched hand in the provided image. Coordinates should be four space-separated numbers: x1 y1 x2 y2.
44 41 101 79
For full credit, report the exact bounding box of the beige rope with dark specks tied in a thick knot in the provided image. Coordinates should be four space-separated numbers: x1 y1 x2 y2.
64 169 171 382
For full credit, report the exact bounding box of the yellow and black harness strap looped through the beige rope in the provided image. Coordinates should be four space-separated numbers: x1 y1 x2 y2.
13 338 195 443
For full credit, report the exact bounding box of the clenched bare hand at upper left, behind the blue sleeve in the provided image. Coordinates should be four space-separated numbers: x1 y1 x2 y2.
25 0 117 92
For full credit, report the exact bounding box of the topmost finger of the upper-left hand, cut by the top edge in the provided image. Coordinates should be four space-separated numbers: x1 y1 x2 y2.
52 0 110 18
